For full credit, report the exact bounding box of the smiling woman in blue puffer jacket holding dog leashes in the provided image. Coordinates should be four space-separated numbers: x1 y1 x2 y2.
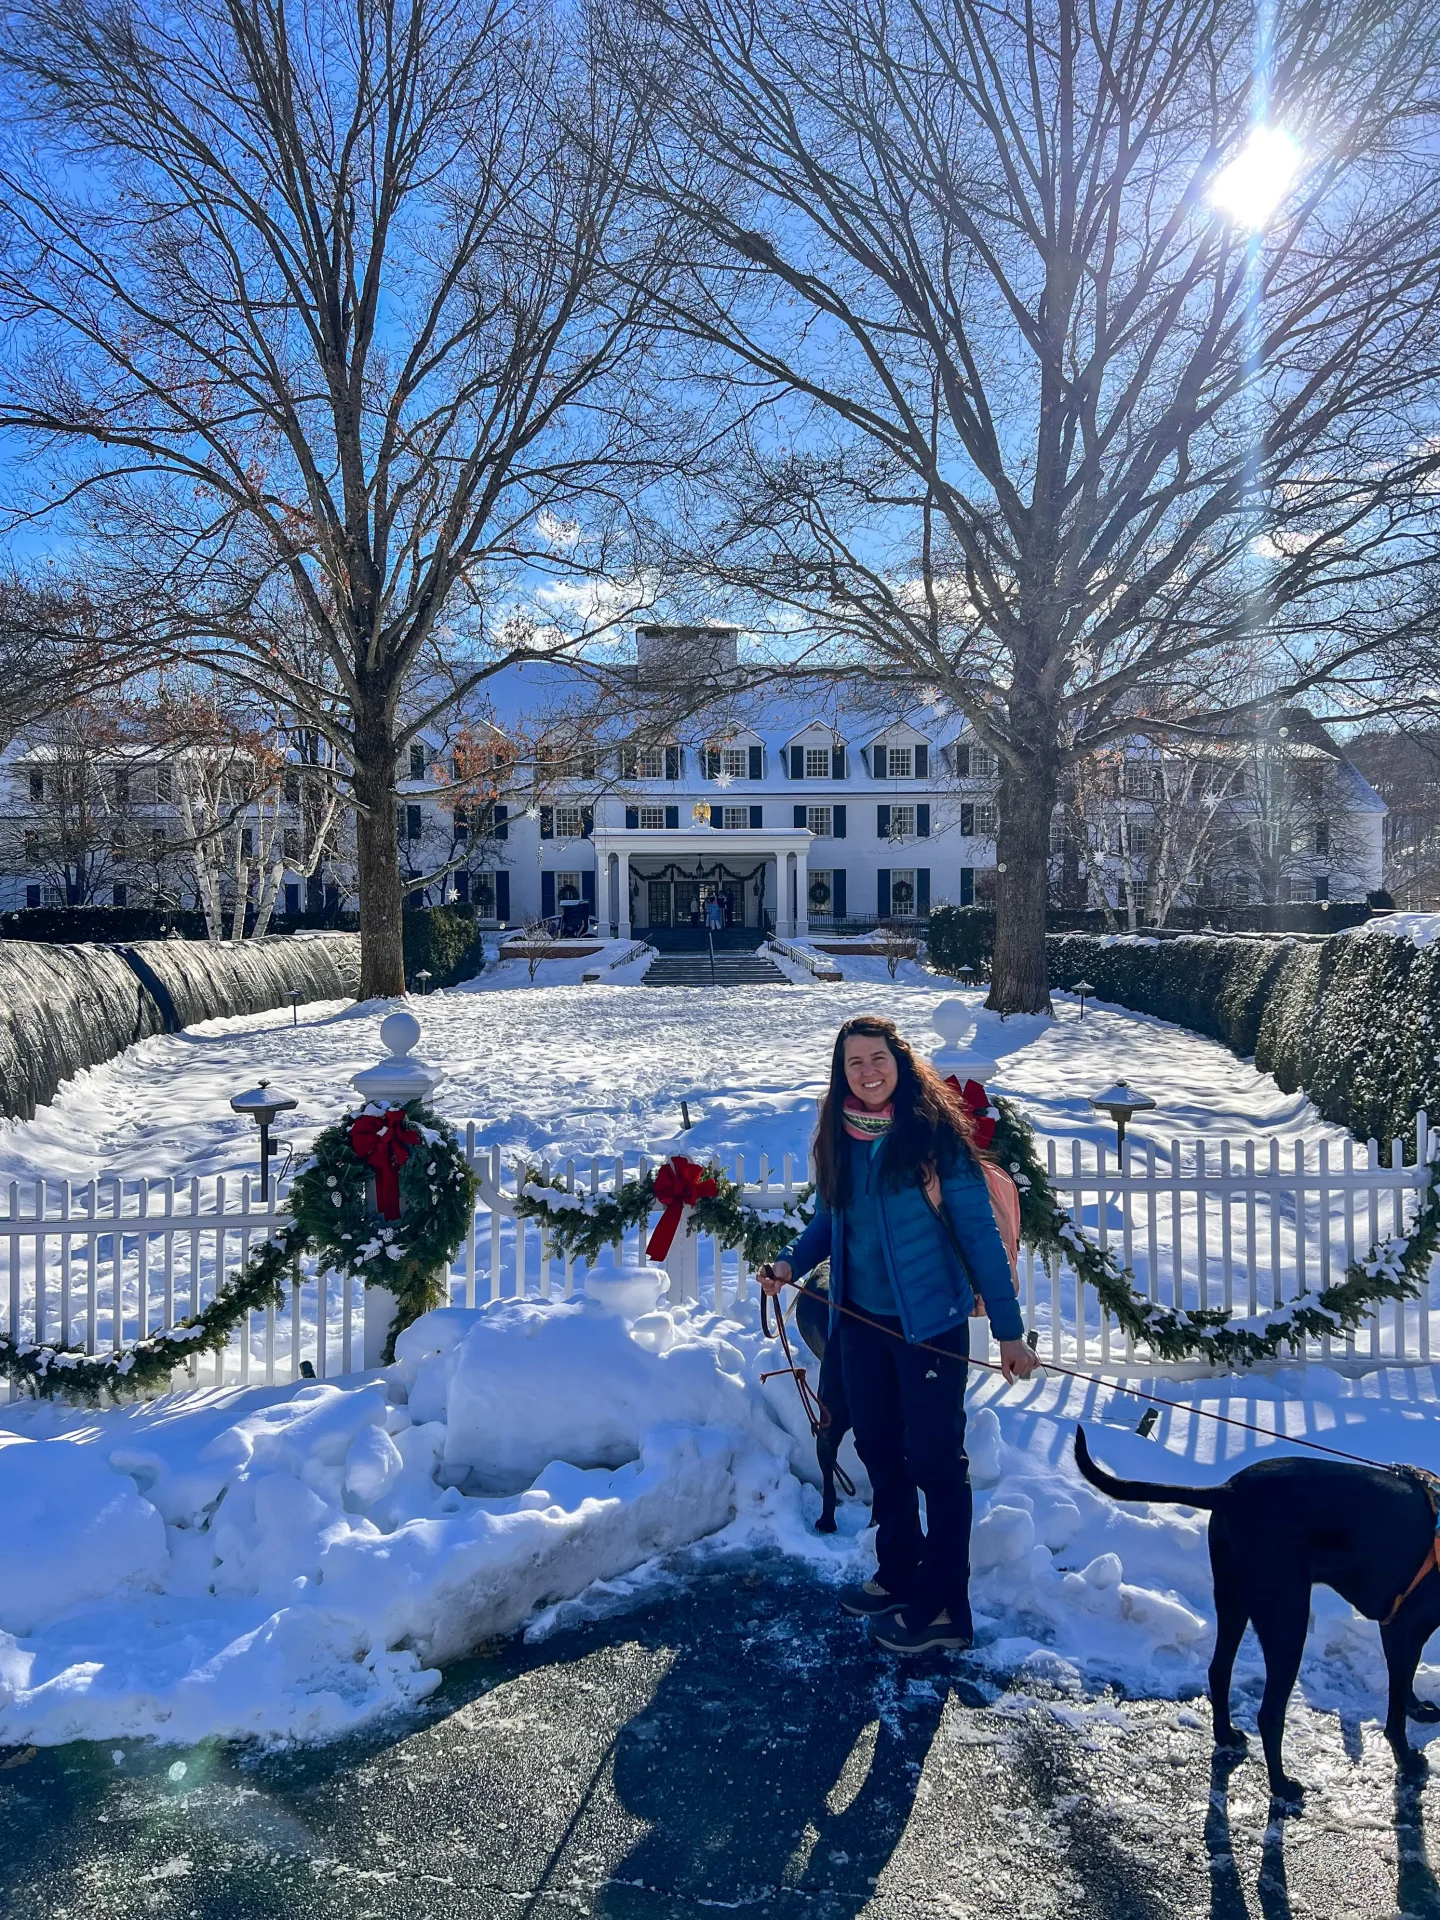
758 1014 1039 1653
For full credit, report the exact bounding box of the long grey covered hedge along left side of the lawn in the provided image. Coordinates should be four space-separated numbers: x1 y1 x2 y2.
0 933 359 1119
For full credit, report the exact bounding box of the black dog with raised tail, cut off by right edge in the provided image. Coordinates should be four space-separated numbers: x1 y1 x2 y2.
1075 1428 1440 1801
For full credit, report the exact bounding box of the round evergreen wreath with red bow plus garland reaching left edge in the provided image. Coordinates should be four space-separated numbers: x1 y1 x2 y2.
0 1100 476 1400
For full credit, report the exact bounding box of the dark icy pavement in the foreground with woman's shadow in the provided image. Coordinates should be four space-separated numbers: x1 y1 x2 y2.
0 1559 1440 1920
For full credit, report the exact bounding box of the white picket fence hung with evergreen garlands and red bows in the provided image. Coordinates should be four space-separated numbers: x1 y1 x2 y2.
0 1114 1432 1386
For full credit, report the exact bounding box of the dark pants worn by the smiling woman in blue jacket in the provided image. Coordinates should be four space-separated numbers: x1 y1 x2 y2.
837 1313 973 1632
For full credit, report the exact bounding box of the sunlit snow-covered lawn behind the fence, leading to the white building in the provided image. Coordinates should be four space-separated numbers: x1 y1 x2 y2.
0 940 1342 1181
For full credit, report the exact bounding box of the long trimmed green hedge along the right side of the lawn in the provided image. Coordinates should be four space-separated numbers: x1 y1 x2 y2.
1044 931 1440 1140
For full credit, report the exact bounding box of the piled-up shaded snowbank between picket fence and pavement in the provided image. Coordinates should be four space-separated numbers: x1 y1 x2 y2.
0 1284 1440 1743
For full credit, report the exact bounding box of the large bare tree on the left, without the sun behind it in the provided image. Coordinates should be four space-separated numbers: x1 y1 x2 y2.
0 0 668 995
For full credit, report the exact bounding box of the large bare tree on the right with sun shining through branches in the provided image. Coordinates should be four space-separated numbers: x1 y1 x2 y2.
611 0 1440 1012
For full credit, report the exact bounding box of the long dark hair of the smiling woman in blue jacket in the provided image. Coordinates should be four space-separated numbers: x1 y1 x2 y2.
814 1014 975 1210
